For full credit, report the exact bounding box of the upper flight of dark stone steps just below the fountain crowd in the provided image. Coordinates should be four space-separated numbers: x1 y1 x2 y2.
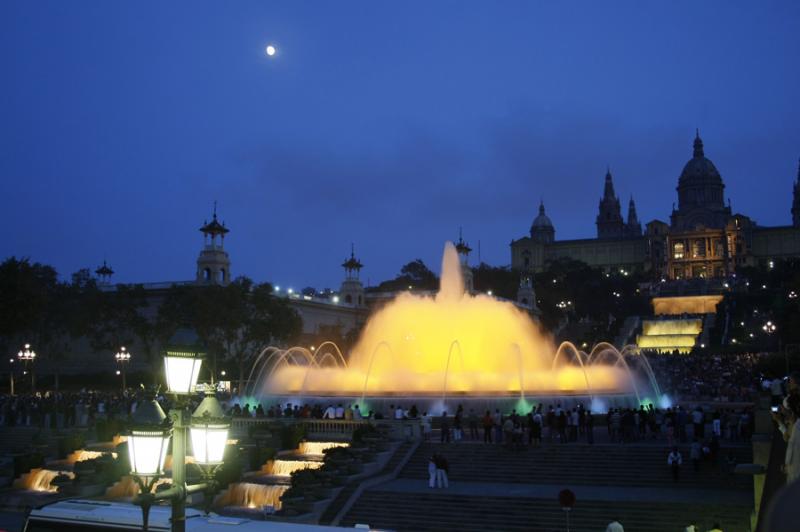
400 443 752 489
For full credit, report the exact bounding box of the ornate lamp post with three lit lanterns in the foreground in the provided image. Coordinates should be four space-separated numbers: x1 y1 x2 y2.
128 348 230 532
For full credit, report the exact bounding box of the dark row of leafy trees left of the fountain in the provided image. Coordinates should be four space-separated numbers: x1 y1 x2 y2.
0 257 302 390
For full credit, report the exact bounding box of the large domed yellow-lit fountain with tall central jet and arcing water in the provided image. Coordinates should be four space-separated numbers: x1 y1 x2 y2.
248 243 659 406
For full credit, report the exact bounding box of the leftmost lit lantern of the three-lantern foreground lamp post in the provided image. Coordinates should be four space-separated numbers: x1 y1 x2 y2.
128 399 170 478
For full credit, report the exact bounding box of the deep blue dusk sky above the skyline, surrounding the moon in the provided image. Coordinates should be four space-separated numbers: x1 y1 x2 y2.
0 0 800 288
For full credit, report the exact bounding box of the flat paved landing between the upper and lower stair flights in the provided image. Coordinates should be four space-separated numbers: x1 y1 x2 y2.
378 478 753 505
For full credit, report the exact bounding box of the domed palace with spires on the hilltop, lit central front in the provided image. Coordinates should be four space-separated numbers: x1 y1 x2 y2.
511 132 800 280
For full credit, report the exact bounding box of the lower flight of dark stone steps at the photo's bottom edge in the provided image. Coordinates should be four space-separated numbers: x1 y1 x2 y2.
341 489 750 532
